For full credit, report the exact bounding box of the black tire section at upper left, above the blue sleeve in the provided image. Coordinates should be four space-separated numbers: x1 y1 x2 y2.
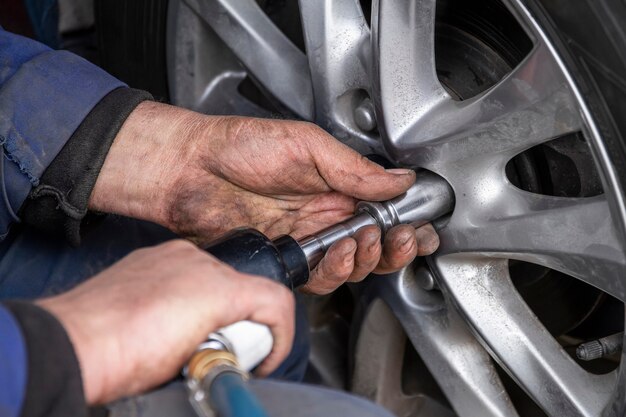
94 0 169 101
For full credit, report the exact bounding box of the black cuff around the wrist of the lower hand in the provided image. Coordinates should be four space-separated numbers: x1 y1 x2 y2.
3 301 88 417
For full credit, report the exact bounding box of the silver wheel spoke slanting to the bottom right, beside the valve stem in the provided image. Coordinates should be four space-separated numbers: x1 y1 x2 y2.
436 254 616 416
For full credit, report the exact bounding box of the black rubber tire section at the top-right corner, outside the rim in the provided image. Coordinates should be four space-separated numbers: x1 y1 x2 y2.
523 0 626 206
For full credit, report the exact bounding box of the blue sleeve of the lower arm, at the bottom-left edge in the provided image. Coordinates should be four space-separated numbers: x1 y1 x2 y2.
0 305 28 417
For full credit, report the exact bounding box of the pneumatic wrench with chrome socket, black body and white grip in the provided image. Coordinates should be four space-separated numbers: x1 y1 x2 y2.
186 171 454 412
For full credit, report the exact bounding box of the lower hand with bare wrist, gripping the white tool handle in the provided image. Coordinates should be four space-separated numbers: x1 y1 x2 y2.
37 240 294 404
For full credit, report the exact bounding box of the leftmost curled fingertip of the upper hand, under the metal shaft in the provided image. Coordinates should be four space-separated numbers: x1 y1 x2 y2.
302 238 357 294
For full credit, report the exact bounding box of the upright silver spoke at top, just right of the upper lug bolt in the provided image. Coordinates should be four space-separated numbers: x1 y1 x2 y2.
372 0 450 153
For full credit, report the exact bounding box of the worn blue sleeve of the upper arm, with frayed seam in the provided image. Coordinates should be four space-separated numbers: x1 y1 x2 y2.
0 28 124 240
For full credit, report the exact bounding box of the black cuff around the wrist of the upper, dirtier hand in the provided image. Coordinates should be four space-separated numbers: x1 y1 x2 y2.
20 88 152 246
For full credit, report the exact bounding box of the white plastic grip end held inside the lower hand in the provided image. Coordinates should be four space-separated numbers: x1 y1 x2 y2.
209 320 274 371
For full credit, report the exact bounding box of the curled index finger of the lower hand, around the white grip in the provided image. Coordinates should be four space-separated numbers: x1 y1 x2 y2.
245 278 295 376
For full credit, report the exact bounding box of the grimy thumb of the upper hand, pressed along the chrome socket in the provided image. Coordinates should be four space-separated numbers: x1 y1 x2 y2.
309 138 415 201
